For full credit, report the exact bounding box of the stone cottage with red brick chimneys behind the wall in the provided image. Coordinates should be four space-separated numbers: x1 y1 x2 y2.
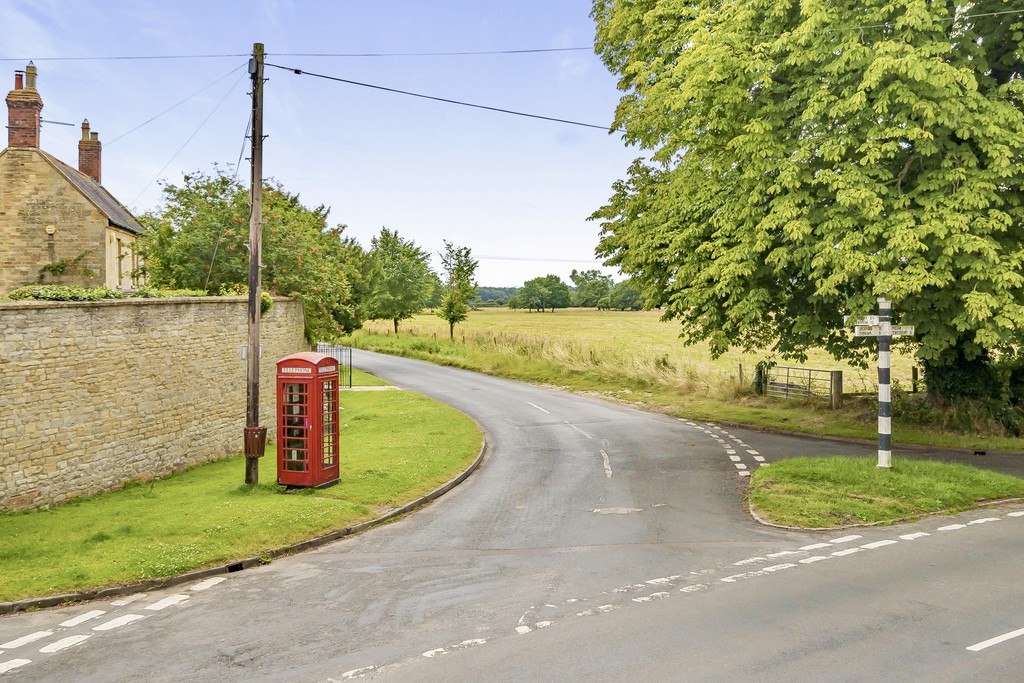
0 62 142 296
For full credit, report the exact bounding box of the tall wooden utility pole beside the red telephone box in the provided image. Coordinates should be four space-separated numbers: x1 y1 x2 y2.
245 43 266 484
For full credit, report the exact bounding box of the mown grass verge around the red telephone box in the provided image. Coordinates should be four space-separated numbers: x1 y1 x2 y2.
0 389 482 601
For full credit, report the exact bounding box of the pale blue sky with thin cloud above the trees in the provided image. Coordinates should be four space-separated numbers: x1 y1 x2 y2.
0 0 637 286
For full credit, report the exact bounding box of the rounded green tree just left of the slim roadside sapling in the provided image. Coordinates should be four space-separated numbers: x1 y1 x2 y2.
367 227 436 334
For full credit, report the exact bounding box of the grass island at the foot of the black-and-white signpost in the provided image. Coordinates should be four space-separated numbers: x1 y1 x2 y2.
748 457 1024 528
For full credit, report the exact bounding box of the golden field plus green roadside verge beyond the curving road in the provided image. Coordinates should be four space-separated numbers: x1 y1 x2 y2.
351 309 1024 451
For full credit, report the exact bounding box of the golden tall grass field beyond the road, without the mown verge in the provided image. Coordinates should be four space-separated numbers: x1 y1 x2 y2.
352 309 913 398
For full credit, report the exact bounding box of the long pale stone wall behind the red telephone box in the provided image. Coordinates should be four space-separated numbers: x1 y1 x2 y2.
0 297 308 510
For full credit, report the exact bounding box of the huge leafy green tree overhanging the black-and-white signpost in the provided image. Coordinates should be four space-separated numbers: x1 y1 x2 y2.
593 0 1024 395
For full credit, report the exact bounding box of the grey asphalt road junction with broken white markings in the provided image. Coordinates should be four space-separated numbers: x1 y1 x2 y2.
0 352 1024 681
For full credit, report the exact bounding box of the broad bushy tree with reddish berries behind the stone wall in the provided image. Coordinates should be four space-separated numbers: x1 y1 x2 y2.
140 169 369 342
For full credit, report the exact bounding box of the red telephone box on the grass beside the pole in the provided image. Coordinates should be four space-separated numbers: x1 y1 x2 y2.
278 352 339 486
